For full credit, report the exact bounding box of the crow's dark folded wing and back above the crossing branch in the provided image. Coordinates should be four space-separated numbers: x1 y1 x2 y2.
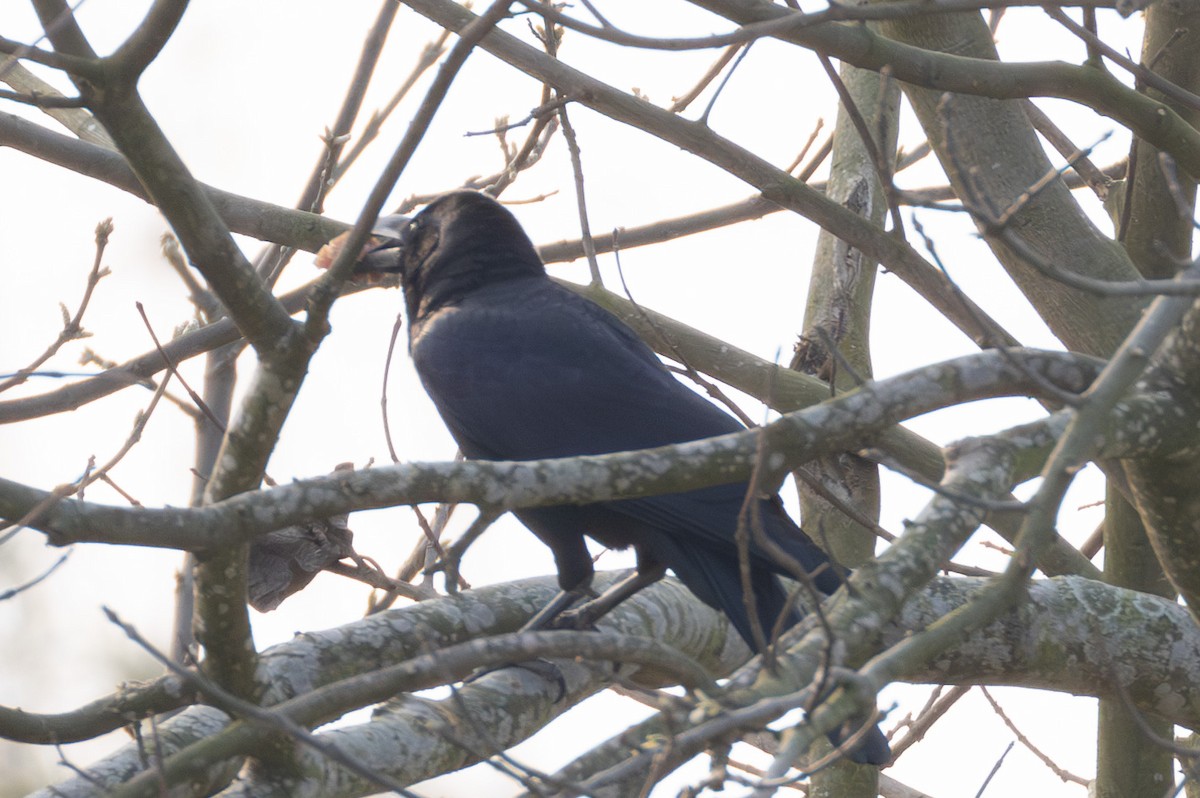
412 278 742 460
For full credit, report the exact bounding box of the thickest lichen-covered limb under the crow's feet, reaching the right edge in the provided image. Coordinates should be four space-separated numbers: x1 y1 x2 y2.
28 577 1200 798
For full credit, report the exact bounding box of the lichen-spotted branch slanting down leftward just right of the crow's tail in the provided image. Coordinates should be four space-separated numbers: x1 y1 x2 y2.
568 422 1013 791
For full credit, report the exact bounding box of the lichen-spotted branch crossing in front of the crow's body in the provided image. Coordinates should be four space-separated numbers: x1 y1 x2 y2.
0 352 1094 552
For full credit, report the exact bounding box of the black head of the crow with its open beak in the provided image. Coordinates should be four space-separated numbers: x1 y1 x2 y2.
356 191 545 320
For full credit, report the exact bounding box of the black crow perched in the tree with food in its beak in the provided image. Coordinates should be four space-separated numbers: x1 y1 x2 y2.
359 191 890 764
